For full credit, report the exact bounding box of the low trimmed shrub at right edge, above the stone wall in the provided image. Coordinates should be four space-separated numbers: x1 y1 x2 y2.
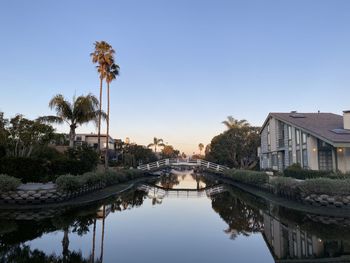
298 178 350 195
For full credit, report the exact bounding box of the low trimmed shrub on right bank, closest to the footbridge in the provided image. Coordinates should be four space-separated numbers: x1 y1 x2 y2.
224 169 269 186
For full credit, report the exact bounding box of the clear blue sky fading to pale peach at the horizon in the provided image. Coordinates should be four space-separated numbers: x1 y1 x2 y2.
0 0 350 153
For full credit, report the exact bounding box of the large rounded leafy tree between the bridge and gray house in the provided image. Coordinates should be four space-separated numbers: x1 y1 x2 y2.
206 120 260 169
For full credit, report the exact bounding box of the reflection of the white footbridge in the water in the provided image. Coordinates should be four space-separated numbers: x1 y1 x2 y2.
137 184 226 199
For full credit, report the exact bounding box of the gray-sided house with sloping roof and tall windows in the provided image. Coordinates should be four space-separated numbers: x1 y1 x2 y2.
258 111 350 172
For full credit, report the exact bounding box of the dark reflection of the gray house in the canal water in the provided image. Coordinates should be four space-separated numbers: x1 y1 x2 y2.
263 213 350 262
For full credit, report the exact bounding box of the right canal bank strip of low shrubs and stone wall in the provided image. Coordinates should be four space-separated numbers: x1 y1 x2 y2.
222 169 350 209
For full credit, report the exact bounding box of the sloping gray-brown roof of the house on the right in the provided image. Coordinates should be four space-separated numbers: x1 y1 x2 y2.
269 112 350 145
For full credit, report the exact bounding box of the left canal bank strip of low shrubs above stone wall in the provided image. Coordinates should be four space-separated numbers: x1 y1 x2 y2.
0 169 152 206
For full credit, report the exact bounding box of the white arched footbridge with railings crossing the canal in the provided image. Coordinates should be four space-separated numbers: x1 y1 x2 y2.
137 159 229 172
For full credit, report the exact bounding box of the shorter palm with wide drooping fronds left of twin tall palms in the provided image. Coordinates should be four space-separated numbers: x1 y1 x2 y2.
38 94 106 147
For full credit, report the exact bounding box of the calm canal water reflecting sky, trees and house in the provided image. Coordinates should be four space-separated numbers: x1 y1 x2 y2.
0 170 350 263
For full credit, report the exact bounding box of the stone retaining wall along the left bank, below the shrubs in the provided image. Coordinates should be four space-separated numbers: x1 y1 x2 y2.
0 183 105 204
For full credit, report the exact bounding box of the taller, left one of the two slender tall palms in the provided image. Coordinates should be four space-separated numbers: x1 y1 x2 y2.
90 41 115 153
